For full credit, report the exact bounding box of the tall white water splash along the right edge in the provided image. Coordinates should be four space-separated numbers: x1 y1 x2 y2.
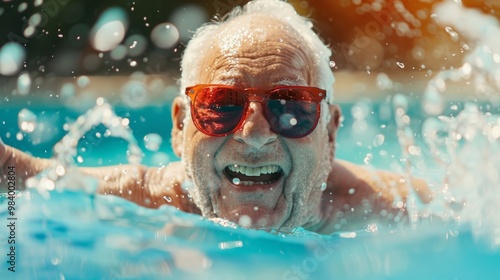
416 1 500 246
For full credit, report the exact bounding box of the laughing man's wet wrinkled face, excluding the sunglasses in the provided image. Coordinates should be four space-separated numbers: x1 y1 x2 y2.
175 17 334 228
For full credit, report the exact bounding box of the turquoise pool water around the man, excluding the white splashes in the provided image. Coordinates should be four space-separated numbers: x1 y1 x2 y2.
0 101 500 279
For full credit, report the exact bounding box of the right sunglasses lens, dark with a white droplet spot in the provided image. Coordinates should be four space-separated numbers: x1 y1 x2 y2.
267 89 319 138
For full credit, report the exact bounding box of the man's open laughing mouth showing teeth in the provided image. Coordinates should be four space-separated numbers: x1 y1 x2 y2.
224 164 283 186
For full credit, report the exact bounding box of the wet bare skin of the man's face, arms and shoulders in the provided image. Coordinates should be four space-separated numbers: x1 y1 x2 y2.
0 16 431 233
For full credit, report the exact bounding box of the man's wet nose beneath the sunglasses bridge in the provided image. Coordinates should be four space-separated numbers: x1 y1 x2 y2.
233 102 278 148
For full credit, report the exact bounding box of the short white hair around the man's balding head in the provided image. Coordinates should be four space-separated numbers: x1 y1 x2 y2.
180 0 335 105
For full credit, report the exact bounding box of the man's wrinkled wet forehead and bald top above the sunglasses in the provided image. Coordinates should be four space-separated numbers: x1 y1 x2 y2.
199 16 313 87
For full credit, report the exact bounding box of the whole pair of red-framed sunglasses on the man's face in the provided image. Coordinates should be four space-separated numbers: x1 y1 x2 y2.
186 84 326 138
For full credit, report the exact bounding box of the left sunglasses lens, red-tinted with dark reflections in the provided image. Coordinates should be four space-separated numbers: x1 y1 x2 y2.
193 87 245 136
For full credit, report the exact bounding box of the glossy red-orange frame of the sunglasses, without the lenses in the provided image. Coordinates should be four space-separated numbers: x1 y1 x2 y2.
185 84 326 138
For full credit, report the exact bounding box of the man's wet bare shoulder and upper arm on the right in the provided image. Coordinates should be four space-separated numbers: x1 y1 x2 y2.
321 160 432 233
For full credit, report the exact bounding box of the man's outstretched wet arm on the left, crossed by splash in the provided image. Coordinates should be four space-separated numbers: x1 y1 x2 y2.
0 139 199 212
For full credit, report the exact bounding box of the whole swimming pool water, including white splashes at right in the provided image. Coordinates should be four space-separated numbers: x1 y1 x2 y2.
0 1 500 279
